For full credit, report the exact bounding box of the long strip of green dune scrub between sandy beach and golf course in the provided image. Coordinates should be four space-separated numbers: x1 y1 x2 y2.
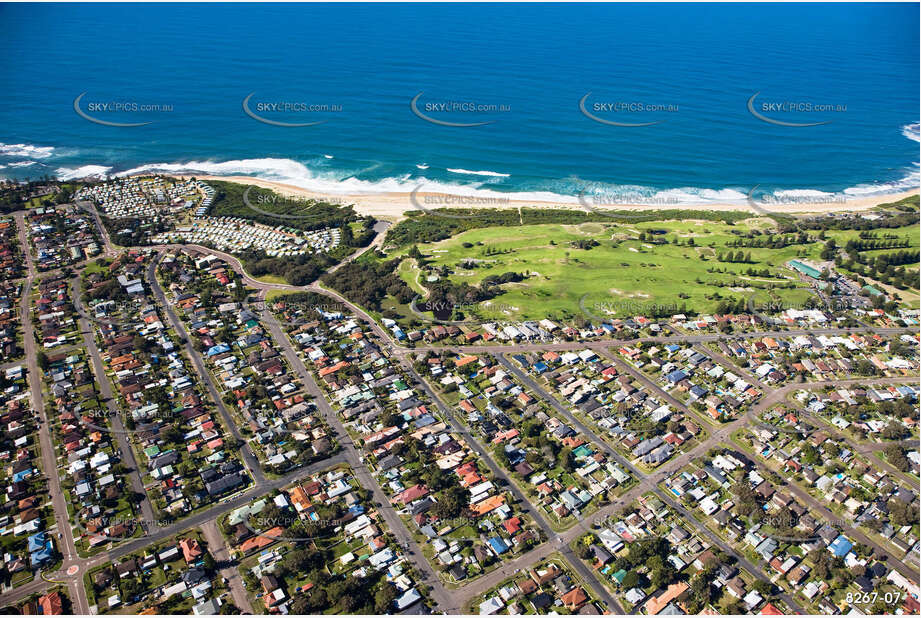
387 208 751 247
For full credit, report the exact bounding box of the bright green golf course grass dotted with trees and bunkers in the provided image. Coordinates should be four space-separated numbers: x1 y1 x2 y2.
388 218 919 319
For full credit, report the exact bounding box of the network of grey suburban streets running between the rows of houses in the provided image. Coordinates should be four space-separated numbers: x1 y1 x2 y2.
3 210 918 614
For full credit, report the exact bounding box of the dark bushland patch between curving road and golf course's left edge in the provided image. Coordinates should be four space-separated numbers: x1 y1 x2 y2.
320 256 416 311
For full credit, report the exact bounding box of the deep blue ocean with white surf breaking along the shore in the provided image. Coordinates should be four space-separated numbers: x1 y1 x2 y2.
0 4 919 201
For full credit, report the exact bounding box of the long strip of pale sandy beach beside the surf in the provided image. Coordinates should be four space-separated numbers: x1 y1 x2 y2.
169 174 918 221
